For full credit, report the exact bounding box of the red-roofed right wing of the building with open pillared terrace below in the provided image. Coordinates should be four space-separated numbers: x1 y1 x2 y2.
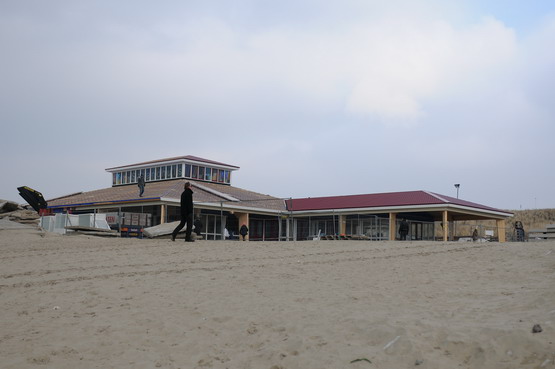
286 191 512 242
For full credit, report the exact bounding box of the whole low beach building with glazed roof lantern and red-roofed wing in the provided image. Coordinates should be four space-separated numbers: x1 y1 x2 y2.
48 155 512 242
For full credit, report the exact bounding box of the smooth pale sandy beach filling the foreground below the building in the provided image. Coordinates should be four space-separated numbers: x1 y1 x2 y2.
0 229 555 369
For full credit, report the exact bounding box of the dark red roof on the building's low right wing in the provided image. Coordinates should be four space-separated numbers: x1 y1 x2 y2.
286 191 506 213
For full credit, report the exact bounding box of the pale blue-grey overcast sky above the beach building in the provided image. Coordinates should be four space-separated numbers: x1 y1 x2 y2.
0 0 555 210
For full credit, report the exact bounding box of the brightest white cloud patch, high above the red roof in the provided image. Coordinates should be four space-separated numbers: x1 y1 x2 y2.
347 19 516 122
